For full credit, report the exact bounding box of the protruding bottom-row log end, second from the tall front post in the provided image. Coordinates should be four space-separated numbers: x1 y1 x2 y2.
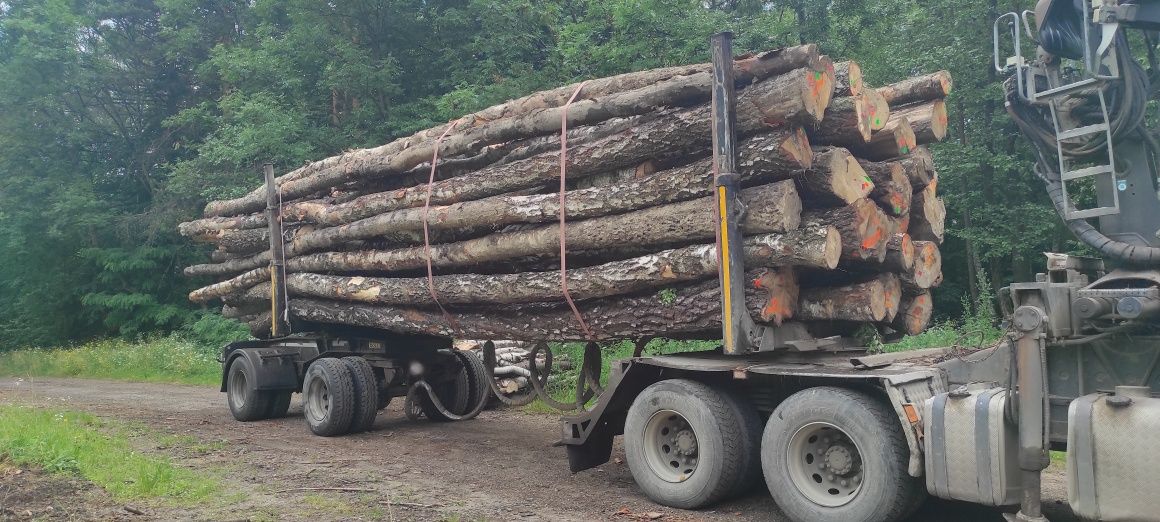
796 273 886 321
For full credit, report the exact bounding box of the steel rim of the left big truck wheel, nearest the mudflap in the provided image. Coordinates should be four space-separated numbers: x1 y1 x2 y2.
643 409 699 484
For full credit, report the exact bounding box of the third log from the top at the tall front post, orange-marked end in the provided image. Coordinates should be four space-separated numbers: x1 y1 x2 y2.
186 129 816 276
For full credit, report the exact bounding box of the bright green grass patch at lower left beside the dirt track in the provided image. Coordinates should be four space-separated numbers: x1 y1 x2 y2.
0 406 220 505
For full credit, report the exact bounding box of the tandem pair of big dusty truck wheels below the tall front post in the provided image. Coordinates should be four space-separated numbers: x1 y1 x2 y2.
624 379 925 522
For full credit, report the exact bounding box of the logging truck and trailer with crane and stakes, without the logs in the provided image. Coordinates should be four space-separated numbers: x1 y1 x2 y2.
222 6 1160 522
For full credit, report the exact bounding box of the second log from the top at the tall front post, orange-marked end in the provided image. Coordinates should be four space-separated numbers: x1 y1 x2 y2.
279 70 825 225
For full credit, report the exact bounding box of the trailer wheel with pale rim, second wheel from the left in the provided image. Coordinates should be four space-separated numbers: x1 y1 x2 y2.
302 357 355 437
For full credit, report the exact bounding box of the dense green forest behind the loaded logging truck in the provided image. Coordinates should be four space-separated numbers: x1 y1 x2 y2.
0 0 1079 350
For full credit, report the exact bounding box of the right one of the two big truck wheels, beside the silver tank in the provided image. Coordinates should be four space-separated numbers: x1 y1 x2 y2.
761 386 925 522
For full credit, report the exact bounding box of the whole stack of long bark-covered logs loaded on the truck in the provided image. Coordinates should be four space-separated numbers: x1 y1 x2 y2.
180 45 950 341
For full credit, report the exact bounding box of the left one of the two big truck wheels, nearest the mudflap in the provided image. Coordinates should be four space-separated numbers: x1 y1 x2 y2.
624 379 753 509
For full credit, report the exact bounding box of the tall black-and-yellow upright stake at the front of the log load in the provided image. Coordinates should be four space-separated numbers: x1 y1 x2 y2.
710 31 754 354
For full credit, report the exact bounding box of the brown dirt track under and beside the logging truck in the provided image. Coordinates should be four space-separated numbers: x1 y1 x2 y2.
0 378 1074 522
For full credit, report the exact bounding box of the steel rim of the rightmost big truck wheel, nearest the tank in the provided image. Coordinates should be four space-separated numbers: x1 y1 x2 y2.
785 422 865 507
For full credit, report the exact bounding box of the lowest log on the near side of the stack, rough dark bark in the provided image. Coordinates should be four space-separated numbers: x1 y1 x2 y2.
290 280 768 341
